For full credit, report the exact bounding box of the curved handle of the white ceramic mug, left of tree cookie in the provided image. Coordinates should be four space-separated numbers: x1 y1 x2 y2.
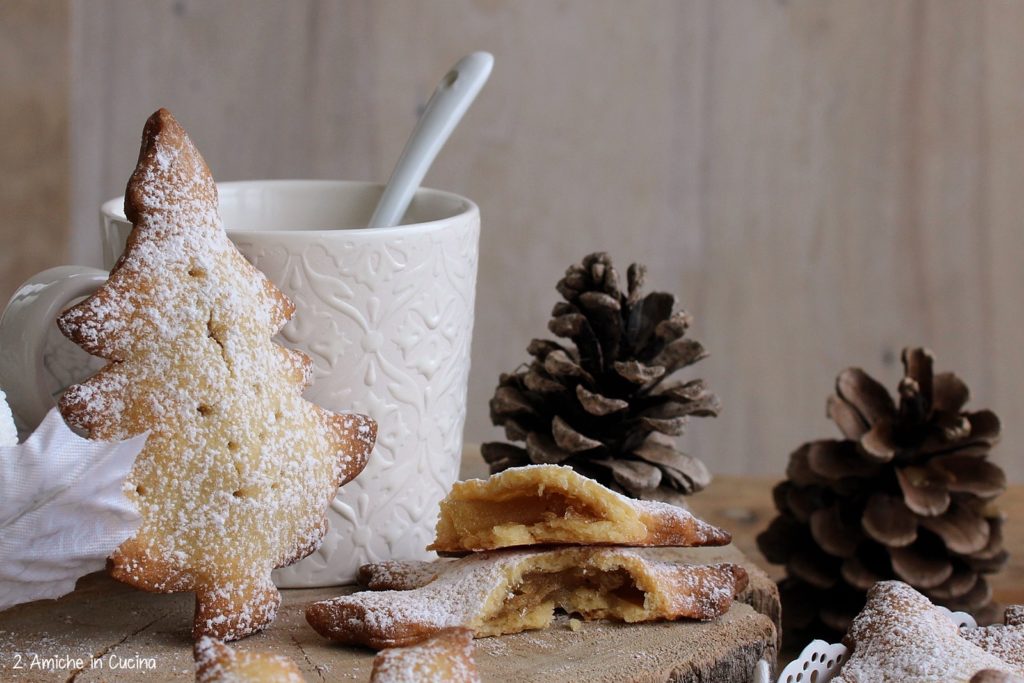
0 265 109 430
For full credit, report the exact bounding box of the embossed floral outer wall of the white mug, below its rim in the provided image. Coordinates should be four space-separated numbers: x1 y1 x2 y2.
237 213 479 586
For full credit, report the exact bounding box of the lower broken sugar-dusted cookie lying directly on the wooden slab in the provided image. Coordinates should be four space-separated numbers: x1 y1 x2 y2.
306 547 746 648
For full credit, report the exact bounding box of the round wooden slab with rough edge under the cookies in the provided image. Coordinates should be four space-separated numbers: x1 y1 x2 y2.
0 546 779 683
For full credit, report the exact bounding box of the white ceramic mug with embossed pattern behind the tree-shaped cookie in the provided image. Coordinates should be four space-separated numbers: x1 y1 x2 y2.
0 180 480 587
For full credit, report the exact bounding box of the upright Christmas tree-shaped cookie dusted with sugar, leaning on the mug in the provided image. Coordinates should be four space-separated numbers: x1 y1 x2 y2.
58 110 376 640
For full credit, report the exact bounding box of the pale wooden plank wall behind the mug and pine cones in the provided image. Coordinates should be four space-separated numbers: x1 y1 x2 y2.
0 0 1024 481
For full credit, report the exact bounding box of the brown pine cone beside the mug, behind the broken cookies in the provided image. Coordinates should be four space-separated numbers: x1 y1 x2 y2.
482 253 719 504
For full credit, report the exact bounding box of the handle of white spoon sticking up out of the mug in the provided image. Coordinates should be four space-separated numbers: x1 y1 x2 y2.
369 52 495 227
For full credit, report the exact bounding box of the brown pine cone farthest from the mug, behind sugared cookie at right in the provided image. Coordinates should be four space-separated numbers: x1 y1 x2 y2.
758 348 1008 642
